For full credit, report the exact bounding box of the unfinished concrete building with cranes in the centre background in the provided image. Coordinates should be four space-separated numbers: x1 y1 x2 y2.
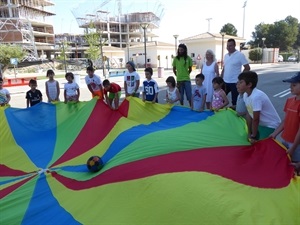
72 0 164 48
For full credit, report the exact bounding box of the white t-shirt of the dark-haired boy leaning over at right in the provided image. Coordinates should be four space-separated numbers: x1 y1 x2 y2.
243 88 281 128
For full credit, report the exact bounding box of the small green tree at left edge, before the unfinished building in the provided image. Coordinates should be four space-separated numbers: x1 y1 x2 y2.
0 44 26 72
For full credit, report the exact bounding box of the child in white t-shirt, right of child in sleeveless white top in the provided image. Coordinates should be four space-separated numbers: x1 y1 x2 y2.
64 72 80 103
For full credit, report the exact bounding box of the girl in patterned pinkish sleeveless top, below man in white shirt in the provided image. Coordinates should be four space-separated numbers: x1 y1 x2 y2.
211 77 229 111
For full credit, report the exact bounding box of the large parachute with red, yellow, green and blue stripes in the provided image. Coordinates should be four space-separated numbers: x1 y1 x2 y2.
0 98 300 225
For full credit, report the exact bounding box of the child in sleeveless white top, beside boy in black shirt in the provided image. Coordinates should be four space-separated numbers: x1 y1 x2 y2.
45 70 60 102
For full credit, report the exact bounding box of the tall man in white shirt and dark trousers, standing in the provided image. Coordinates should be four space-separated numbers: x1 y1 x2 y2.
221 38 250 109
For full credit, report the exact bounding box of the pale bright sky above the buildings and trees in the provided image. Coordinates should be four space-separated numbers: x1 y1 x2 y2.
52 0 300 43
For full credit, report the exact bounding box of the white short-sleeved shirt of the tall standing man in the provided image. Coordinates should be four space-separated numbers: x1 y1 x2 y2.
223 50 248 83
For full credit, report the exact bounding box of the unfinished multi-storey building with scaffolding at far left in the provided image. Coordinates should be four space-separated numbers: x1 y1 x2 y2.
0 0 55 61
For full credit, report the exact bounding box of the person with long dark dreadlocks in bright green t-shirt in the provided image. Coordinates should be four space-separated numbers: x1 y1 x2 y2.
172 44 193 107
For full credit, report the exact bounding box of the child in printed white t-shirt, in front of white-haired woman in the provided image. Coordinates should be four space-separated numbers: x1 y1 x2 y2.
191 73 207 112
